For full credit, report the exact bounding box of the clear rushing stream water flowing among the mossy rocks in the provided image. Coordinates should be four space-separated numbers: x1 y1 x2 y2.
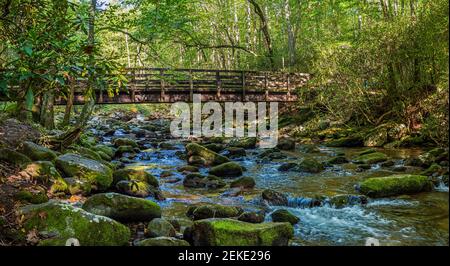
97 123 449 245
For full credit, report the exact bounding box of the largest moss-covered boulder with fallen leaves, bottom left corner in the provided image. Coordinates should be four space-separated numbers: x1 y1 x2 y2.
20 201 131 246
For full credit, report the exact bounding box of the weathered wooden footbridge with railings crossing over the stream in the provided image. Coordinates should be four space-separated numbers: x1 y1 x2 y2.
0 68 310 105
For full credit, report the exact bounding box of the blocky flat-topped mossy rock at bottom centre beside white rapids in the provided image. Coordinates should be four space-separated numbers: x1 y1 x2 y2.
190 218 294 246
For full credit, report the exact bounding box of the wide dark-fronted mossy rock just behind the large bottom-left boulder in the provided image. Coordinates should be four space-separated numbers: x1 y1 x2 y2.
82 193 161 222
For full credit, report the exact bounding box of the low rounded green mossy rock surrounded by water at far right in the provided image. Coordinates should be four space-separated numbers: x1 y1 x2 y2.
359 175 433 198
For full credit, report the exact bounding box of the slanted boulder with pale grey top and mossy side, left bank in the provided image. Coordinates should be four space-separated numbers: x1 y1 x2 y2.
56 153 113 190
